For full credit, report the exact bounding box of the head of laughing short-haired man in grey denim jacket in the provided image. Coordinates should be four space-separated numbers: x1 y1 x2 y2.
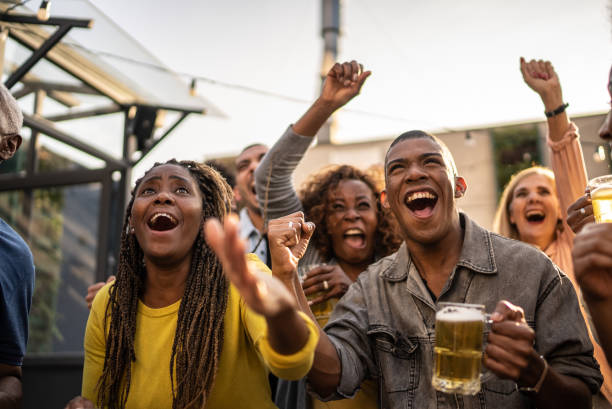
383 137 466 245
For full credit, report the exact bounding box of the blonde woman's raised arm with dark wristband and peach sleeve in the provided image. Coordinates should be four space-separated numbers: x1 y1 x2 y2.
521 57 587 220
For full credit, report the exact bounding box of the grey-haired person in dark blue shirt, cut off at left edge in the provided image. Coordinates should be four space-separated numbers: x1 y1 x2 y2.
0 84 34 409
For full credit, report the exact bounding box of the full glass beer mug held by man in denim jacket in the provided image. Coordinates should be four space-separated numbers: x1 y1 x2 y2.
432 302 488 395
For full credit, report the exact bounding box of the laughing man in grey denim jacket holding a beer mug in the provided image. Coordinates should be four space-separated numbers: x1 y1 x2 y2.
290 127 602 409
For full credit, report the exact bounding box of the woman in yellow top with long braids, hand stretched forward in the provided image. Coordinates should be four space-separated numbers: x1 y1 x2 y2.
68 160 318 409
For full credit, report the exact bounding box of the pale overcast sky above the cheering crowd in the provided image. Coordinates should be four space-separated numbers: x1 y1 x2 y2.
40 0 612 177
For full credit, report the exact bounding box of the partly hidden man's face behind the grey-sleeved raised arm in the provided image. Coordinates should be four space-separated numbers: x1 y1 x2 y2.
234 145 268 212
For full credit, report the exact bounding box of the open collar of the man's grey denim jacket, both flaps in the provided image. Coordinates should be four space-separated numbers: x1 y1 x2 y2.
381 212 497 281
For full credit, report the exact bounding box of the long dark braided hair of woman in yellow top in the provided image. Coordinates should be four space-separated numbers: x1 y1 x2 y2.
97 159 232 409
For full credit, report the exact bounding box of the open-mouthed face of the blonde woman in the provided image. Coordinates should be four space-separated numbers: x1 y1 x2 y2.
508 173 561 250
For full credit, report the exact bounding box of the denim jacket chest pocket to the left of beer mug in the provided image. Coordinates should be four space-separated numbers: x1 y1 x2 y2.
368 325 420 393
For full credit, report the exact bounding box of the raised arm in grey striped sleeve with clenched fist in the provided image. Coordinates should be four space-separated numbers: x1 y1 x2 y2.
255 61 370 220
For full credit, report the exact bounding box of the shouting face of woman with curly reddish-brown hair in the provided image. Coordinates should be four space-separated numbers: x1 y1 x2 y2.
325 179 378 264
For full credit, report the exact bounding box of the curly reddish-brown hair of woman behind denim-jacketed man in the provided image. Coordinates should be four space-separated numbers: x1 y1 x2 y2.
299 165 402 260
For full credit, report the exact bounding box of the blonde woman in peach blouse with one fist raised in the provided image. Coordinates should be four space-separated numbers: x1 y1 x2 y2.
493 58 612 408
